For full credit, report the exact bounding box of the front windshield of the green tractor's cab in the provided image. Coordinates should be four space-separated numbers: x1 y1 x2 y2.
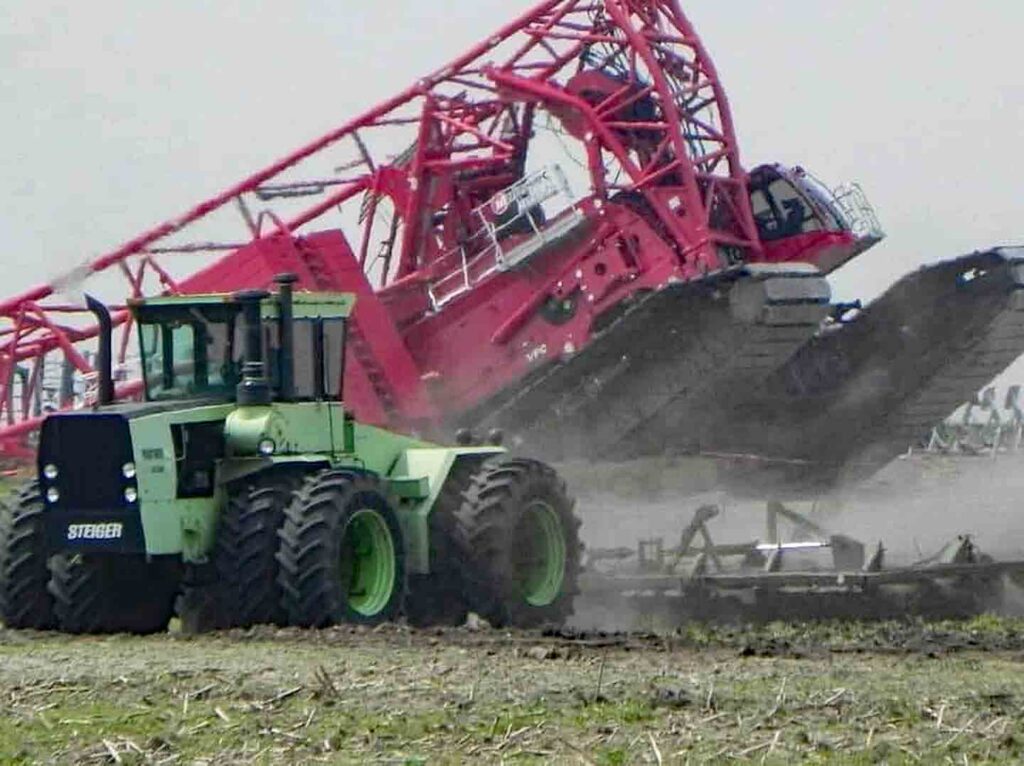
138 305 241 400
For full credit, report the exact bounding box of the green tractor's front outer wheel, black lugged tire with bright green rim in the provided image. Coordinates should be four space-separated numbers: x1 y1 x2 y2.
278 470 406 628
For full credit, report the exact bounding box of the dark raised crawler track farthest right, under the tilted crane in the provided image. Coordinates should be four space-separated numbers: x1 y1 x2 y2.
702 248 1024 491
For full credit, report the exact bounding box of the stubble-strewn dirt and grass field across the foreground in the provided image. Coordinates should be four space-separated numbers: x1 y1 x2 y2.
6 618 1024 764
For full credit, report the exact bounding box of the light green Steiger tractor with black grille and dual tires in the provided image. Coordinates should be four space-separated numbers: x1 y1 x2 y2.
0 274 581 633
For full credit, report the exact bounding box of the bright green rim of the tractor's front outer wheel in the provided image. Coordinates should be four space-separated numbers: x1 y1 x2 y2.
341 508 396 618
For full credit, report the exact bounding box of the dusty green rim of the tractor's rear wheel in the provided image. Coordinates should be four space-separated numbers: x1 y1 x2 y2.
515 500 565 606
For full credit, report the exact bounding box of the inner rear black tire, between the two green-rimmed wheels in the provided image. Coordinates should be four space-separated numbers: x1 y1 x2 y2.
402 460 480 628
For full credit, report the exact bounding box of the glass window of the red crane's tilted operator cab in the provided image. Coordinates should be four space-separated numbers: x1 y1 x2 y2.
751 167 844 242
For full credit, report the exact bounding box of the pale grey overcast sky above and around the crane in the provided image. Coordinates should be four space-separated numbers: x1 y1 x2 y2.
0 0 1024 370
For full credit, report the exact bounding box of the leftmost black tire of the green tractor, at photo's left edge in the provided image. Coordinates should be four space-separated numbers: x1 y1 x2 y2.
0 481 56 630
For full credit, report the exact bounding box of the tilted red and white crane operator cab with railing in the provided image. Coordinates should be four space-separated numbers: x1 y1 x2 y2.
750 165 885 273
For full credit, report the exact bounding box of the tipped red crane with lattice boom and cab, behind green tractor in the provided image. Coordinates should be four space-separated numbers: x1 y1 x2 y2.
0 0 881 456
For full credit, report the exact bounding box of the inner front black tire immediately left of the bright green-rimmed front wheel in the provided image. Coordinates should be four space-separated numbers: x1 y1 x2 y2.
177 471 302 633
